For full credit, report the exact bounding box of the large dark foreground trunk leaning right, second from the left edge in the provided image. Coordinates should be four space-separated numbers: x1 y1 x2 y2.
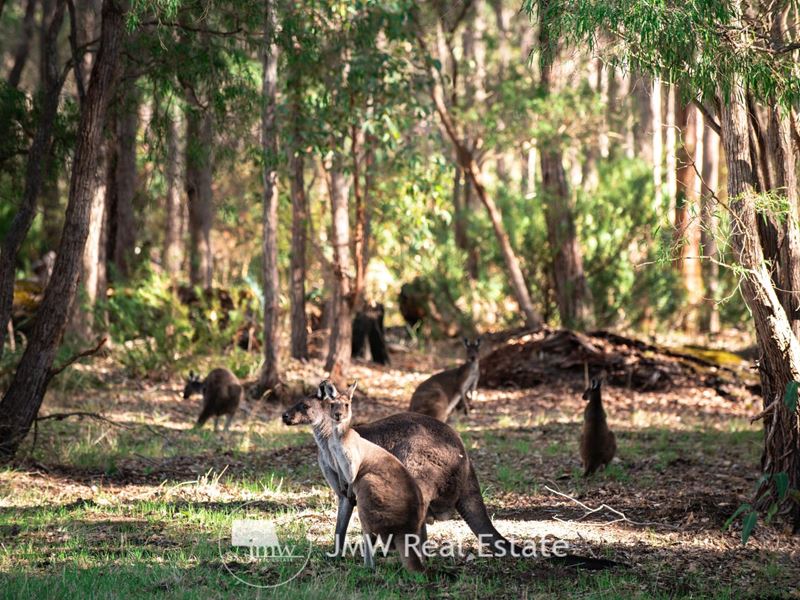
0 0 124 459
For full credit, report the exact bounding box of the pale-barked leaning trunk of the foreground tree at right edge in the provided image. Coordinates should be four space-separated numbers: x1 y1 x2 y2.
721 80 800 531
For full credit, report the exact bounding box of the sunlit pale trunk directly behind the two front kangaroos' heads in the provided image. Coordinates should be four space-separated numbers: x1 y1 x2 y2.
325 157 352 380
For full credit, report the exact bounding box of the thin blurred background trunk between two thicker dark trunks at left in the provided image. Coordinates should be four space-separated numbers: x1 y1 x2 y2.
162 105 183 284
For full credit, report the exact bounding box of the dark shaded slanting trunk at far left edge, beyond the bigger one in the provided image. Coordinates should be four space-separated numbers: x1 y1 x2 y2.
0 0 65 356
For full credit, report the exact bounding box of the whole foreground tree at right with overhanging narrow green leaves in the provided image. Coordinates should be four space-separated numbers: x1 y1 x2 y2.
526 0 800 531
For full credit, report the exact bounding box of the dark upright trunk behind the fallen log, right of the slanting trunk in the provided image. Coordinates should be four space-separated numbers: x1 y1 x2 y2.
539 11 592 328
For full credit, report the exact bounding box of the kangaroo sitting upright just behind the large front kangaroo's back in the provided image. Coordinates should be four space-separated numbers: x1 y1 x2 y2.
408 338 481 423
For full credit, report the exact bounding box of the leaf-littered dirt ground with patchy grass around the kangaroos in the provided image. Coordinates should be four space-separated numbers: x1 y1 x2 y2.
0 330 800 598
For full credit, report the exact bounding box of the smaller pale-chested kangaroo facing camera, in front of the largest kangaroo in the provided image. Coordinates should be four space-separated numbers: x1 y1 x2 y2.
327 383 427 573
